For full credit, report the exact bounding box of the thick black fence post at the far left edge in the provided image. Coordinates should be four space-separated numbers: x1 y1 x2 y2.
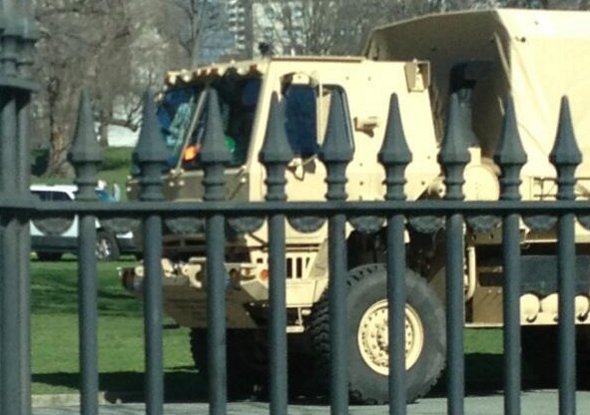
0 4 37 415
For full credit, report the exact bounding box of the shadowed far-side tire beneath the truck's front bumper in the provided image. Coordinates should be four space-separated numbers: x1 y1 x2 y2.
190 329 268 398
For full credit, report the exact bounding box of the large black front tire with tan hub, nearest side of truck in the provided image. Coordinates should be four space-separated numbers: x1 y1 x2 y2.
309 264 446 404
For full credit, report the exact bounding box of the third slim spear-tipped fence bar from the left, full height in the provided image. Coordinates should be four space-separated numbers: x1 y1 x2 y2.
201 89 231 415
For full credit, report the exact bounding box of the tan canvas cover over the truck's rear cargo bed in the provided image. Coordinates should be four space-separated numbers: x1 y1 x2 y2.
365 9 590 177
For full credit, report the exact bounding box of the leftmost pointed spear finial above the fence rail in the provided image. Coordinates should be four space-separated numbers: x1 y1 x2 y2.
68 90 102 200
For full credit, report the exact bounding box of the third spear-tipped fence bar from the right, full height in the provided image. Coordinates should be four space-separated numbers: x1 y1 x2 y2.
438 94 470 415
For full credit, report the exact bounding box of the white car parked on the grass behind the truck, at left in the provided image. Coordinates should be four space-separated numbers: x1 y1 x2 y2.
30 184 137 261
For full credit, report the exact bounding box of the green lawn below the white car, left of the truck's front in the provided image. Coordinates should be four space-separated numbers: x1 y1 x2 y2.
31 259 199 394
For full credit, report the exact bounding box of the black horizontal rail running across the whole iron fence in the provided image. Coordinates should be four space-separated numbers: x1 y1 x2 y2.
12 200 590 216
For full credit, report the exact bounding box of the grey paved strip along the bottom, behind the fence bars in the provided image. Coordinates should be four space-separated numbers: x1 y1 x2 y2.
33 390 590 415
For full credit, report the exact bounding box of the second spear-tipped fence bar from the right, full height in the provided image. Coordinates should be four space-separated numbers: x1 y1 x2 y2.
494 99 527 415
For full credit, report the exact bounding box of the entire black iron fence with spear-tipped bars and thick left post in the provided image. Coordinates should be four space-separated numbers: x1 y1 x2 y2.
0 4 590 415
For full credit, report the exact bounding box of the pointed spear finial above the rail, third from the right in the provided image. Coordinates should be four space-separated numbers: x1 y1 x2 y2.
438 94 471 200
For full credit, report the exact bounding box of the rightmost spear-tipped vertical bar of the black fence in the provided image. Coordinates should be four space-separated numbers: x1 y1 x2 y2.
549 97 582 415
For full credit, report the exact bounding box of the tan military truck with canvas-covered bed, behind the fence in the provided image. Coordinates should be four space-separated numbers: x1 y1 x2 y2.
122 10 590 402
